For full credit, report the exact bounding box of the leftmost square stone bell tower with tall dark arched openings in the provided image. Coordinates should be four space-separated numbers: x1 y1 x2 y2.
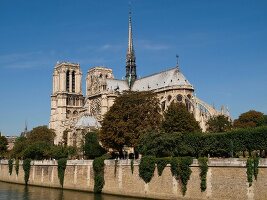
49 62 84 144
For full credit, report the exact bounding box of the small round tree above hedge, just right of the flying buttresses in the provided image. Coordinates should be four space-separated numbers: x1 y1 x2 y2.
207 115 232 133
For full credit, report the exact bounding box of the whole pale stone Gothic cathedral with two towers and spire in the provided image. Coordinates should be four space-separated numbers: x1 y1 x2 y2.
49 13 229 146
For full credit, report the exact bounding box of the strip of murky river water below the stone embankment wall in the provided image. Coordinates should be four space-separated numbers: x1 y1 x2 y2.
0 182 147 200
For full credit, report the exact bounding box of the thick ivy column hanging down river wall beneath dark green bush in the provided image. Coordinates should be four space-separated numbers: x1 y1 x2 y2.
93 155 107 193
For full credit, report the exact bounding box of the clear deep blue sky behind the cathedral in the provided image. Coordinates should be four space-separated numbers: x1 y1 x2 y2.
0 0 267 135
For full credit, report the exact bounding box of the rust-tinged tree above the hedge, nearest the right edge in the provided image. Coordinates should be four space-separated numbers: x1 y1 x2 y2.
234 110 264 128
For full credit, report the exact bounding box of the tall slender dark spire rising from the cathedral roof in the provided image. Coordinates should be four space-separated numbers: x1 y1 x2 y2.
126 8 137 88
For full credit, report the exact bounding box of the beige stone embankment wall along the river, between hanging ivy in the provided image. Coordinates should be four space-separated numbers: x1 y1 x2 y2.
0 158 267 200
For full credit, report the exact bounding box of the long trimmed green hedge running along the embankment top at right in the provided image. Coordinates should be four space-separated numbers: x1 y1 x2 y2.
138 126 267 157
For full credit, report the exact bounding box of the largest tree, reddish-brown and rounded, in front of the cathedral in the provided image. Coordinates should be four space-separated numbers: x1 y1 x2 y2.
100 91 162 151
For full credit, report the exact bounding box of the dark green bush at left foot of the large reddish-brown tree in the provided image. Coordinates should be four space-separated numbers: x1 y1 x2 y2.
84 132 106 159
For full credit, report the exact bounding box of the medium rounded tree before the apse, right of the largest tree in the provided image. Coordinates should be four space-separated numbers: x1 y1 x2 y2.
162 102 201 133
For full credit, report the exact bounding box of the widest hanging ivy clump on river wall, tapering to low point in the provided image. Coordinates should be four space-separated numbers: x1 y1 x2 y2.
171 157 193 195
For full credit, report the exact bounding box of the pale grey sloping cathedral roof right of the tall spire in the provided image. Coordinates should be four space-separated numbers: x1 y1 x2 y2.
132 67 194 91
